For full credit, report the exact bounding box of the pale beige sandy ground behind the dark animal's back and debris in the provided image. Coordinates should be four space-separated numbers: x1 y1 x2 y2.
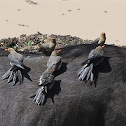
0 0 126 46
